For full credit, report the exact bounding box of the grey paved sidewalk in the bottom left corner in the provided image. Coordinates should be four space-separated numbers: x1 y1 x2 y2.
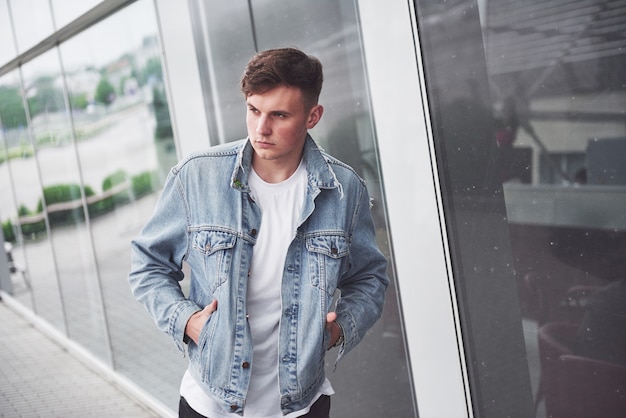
0 301 163 418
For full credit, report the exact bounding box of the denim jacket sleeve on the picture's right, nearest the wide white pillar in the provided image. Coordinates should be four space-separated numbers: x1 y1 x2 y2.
336 181 389 360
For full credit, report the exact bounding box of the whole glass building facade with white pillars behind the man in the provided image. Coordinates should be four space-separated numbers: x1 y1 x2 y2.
0 0 626 418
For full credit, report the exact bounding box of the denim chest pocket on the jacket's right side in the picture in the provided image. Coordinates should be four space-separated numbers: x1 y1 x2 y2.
306 234 350 295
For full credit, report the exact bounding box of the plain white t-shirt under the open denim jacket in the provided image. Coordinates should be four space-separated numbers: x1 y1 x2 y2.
180 163 334 418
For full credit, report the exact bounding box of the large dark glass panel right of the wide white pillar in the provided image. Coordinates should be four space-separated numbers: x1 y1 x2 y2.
415 0 626 417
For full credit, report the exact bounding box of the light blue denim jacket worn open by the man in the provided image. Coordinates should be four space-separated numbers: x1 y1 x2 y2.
129 136 389 415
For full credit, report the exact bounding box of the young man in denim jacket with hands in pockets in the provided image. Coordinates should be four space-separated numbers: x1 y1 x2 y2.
129 48 389 418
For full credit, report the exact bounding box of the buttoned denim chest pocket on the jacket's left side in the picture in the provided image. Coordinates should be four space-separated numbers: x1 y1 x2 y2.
193 230 237 294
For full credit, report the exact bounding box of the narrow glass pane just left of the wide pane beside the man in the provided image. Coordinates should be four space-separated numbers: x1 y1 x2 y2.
24 49 109 361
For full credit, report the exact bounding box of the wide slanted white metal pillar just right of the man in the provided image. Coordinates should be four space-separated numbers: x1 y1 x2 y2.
358 0 473 417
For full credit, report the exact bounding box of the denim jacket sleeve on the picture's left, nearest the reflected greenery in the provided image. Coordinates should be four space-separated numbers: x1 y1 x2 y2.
128 171 202 352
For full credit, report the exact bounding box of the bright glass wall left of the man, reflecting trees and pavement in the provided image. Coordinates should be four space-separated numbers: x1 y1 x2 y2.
0 1 185 409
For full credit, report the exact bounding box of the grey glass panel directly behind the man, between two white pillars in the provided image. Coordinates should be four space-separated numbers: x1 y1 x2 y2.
192 0 417 417
